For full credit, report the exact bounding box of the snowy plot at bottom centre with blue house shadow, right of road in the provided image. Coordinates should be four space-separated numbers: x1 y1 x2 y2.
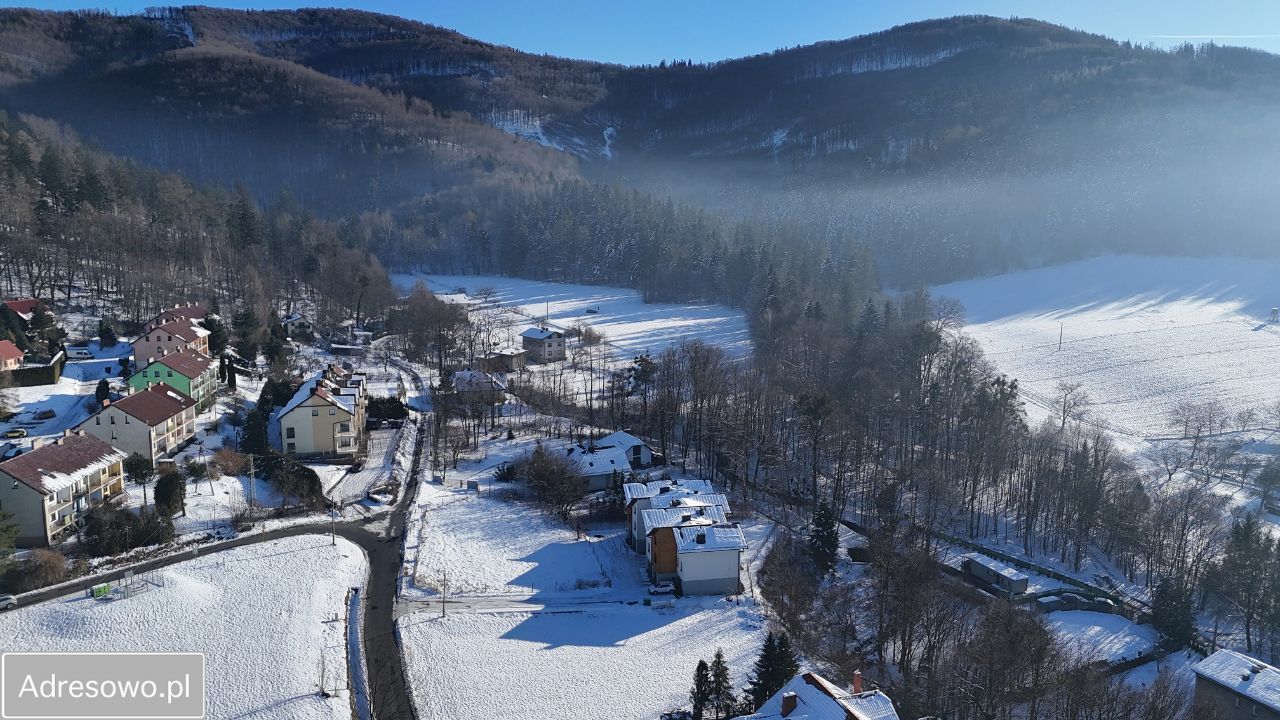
399 601 764 720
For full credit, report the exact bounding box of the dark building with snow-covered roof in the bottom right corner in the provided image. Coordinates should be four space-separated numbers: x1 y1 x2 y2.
1192 650 1280 720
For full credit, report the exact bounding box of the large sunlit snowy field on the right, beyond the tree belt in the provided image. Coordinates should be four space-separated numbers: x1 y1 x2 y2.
933 256 1280 441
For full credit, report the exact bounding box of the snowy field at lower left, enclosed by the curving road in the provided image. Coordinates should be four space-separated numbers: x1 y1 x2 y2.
0 536 367 719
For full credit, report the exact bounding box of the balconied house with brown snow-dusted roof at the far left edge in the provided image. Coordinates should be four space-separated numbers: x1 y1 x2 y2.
0 432 125 547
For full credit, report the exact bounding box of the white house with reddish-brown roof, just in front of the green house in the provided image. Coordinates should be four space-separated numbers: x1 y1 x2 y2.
76 383 196 464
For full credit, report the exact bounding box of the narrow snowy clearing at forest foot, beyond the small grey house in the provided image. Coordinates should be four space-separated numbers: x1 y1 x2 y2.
392 274 751 359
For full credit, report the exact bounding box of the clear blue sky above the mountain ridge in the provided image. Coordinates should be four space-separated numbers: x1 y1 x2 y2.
17 0 1280 64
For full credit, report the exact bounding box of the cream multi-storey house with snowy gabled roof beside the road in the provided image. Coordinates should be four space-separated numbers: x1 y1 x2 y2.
276 365 367 457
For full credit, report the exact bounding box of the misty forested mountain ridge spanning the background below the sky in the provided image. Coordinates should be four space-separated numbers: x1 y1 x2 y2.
0 8 1280 287
